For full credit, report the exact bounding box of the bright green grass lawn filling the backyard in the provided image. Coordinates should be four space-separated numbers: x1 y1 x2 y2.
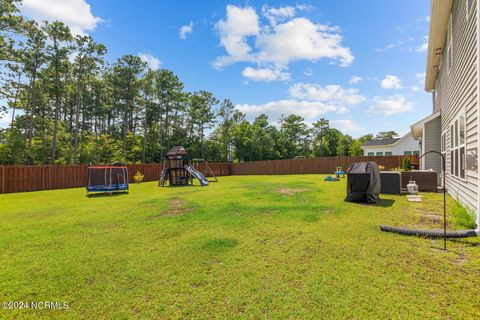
0 175 480 319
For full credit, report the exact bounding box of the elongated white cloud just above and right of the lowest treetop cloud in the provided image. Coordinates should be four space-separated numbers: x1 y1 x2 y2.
289 83 366 107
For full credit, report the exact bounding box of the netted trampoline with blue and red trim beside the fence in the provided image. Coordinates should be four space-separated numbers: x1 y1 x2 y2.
87 165 128 196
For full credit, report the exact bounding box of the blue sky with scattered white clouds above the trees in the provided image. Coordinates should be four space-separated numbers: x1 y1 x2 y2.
0 0 432 137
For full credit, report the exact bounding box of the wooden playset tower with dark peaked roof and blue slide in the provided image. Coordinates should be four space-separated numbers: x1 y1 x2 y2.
158 146 208 187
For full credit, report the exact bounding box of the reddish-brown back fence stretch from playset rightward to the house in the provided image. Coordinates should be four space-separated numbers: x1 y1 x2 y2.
231 156 418 175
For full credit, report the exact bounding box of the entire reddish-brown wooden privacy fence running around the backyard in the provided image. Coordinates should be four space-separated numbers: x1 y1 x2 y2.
0 156 418 193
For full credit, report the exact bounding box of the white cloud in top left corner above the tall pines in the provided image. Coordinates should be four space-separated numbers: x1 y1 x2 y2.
20 0 103 34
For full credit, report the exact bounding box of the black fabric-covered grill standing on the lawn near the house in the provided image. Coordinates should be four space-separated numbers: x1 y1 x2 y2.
345 162 381 204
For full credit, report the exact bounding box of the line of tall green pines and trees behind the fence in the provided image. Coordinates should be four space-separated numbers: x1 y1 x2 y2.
0 0 397 164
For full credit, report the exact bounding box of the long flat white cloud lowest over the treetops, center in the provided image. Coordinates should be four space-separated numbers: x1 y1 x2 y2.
236 100 342 121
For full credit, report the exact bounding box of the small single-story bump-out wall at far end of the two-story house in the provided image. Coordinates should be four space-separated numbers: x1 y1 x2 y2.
421 117 442 173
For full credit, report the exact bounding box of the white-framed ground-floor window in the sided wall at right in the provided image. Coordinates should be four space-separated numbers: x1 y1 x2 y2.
450 115 465 179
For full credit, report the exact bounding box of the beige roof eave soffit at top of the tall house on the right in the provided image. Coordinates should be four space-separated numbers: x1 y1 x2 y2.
425 0 453 91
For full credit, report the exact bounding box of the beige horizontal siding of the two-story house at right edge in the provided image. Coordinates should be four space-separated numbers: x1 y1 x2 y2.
435 0 478 212
